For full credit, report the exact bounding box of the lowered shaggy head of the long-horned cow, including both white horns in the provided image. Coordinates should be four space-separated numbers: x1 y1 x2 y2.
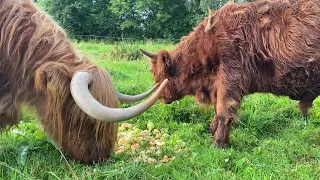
35 61 167 164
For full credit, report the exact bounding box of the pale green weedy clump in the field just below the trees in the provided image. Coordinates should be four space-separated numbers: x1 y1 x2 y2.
110 42 143 61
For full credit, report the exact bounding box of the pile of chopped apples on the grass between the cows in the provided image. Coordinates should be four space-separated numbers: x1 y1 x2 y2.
115 122 190 163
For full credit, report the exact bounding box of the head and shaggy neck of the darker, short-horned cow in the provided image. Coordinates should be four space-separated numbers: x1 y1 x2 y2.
140 8 219 103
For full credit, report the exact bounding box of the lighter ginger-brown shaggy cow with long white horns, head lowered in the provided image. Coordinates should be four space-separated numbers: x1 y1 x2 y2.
0 0 167 163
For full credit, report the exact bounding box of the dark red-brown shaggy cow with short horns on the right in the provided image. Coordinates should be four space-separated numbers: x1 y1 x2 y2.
141 0 320 147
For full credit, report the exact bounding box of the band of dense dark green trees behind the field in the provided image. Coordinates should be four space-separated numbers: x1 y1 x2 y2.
38 0 252 40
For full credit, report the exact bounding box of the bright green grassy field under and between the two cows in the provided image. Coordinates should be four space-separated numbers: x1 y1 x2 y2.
0 43 320 179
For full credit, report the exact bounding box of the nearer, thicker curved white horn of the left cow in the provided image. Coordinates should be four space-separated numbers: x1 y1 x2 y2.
70 72 168 122
